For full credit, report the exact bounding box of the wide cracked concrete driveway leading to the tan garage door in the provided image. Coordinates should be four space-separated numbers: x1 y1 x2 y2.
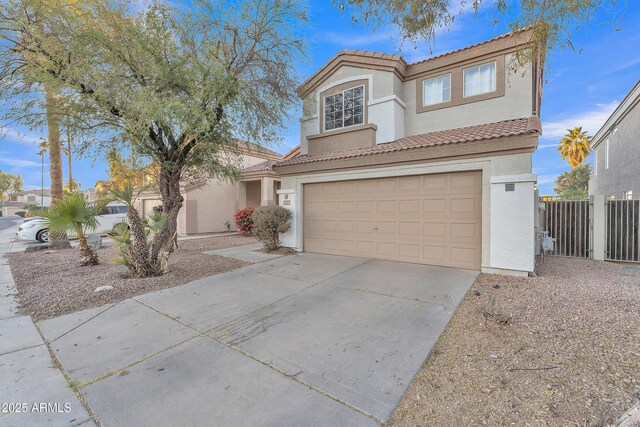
39 249 477 426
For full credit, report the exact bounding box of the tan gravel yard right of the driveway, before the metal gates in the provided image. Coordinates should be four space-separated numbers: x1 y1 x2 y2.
389 257 640 426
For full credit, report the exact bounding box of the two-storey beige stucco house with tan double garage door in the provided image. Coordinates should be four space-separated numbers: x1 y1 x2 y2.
274 30 543 275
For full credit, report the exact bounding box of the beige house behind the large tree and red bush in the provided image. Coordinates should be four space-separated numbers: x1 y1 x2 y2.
138 143 283 235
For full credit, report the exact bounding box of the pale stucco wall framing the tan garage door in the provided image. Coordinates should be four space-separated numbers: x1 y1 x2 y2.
279 153 536 274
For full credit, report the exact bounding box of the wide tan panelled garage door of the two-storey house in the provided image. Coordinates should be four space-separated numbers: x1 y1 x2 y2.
303 171 482 269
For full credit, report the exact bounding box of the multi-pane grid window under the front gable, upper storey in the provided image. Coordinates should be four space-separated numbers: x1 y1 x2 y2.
324 86 364 130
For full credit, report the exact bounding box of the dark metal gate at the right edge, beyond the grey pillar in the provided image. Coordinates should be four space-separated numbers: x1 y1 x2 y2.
605 200 640 262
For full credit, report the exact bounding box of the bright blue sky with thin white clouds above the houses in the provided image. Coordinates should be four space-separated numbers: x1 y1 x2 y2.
0 0 640 194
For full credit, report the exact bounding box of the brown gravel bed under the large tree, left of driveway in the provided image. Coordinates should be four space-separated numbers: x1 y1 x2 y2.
6 235 256 321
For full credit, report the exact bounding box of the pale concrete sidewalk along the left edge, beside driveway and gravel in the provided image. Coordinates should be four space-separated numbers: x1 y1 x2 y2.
0 221 95 426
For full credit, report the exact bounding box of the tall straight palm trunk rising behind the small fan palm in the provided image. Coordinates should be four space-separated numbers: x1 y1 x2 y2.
44 83 71 249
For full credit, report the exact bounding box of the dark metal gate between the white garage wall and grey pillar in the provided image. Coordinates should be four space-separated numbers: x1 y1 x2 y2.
542 198 592 258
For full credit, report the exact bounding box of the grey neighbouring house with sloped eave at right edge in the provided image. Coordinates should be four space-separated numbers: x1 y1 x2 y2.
589 81 640 198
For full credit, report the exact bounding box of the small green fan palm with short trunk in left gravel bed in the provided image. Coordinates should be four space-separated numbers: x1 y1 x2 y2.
38 193 106 267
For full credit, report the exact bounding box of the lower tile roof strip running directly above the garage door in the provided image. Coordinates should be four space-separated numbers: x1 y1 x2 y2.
274 116 542 168
